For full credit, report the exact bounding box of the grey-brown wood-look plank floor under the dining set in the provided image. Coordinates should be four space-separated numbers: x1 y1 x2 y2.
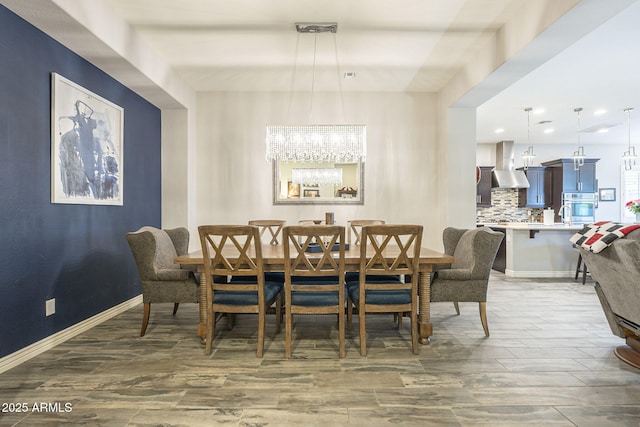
0 273 640 427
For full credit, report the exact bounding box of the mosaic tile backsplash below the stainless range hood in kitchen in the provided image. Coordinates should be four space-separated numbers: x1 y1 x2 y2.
476 188 543 222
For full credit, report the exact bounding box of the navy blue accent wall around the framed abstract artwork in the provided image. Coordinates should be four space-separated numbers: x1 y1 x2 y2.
0 6 161 357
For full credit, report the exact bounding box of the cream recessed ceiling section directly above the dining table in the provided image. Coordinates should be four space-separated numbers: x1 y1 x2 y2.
106 0 521 92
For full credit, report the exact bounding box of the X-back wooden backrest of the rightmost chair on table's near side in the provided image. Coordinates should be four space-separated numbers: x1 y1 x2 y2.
360 224 423 282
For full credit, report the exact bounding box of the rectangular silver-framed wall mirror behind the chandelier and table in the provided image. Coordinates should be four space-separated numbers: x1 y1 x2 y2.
272 160 364 205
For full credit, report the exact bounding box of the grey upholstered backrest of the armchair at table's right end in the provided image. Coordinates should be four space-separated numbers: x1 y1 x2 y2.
451 227 504 280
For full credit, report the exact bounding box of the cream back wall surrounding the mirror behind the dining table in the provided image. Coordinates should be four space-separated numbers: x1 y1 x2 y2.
195 92 444 249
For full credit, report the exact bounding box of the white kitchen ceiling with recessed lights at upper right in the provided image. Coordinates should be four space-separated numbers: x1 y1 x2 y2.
477 2 640 145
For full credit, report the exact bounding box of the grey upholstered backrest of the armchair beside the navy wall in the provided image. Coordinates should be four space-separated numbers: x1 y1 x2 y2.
125 226 189 281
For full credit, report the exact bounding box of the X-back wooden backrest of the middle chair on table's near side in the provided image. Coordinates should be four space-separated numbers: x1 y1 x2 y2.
283 225 345 282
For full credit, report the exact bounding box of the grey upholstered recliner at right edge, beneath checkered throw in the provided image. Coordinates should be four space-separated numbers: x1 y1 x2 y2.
580 229 640 369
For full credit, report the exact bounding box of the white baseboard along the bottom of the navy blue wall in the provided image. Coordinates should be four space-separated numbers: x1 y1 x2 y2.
0 295 142 374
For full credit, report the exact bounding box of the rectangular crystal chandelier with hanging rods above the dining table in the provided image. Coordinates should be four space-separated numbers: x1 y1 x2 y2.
266 23 367 163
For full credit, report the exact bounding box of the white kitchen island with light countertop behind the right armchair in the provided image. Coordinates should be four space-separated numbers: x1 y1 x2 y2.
478 222 583 278
